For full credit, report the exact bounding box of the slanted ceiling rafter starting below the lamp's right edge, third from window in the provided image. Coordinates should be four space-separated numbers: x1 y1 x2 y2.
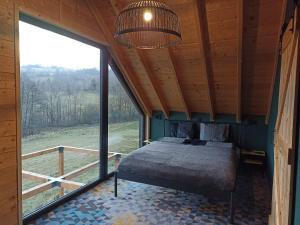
168 48 191 120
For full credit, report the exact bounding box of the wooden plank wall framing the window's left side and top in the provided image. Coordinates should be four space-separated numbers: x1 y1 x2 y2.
0 0 106 225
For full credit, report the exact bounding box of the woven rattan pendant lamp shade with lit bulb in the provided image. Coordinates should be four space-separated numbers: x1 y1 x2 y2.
114 1 181 49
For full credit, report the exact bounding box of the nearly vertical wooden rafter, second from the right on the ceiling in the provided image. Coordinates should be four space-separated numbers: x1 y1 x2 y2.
236 0 244 123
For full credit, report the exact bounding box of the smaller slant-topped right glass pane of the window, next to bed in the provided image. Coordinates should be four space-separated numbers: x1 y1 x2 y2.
108 67 141 172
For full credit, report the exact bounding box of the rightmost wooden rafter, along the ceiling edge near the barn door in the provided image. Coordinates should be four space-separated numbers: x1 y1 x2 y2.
265 0 287 124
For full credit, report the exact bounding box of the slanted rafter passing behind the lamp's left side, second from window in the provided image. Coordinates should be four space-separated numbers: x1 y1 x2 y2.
110 0 170 118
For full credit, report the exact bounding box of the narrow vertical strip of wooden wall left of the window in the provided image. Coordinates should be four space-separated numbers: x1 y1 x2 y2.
0 0 19 225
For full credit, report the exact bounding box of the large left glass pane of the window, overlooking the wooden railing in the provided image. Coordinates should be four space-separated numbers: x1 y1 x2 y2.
20 22 100 215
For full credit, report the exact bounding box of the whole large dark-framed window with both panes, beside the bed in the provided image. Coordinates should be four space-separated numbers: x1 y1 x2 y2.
19 15 143 221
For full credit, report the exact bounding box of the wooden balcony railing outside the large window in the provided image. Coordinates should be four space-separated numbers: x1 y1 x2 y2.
22 146 122 200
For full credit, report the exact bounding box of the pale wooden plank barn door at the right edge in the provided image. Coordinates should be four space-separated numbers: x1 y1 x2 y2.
270 13 300 225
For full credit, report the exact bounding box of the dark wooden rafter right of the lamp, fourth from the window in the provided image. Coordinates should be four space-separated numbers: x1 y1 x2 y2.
195 0 215 121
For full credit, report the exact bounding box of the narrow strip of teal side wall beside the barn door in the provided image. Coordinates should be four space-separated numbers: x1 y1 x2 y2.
267 62 280 178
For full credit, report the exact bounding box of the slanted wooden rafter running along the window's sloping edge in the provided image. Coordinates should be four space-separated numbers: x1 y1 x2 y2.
86 0 152 117
